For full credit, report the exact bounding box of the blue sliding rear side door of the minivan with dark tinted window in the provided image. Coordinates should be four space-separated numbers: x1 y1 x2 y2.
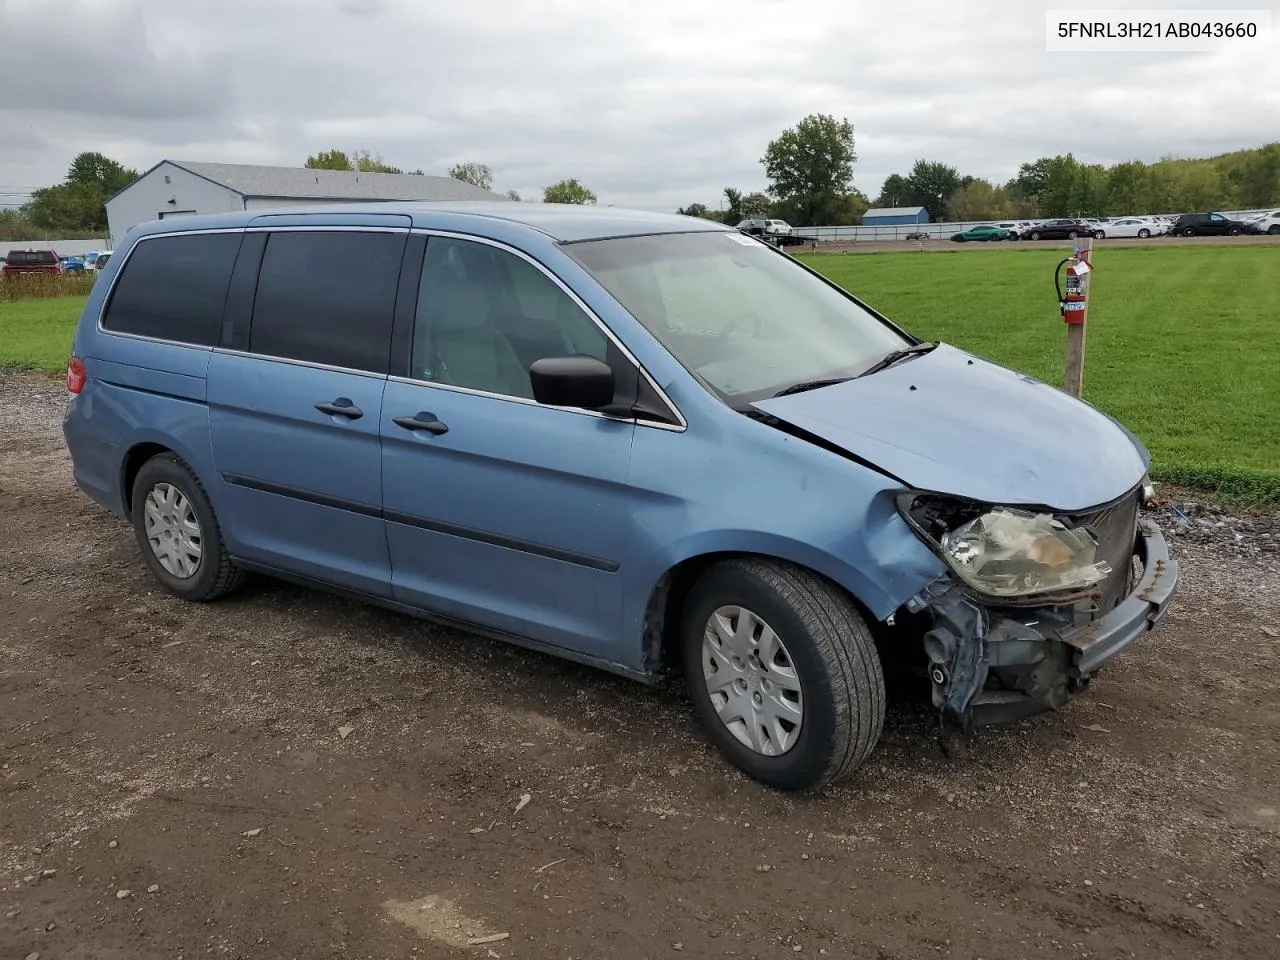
209 229 407 596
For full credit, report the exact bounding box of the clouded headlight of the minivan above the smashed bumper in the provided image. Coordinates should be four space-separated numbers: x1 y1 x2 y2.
940 508 1111 596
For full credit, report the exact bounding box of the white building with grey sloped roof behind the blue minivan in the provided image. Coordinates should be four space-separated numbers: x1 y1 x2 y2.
106 160 504 247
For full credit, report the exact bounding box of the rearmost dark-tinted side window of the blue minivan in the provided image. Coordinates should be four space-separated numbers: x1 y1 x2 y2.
102 233 243 347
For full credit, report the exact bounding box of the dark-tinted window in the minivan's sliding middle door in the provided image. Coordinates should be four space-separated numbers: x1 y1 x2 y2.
248 230 406 374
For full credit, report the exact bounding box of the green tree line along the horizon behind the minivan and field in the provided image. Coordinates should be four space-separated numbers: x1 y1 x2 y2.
10 138 1280 241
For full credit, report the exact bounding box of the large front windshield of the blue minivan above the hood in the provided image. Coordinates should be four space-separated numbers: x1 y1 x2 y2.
563 232 909 406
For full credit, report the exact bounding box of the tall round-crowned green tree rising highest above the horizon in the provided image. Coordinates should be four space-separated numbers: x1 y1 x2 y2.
760 114 858 225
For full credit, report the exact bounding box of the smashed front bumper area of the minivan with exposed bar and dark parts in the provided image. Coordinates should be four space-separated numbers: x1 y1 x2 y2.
908 520 1178 728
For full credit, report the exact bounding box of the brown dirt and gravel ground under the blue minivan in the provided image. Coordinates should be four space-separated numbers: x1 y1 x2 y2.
0 374 1280 960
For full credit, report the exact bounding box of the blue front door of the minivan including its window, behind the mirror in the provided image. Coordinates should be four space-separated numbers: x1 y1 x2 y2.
381 237 636 660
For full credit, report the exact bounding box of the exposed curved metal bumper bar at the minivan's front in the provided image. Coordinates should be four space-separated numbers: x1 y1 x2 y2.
1062 521 1178 678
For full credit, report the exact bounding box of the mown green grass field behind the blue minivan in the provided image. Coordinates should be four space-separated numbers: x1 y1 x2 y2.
0 244 1280 503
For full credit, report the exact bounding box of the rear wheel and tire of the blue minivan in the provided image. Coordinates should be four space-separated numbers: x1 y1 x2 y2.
131 453 246 603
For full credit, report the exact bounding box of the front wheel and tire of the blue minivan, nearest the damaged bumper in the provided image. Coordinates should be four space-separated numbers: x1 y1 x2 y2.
681 559 884 791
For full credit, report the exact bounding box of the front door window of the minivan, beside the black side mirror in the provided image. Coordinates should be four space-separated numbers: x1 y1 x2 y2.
411 237 608 399
